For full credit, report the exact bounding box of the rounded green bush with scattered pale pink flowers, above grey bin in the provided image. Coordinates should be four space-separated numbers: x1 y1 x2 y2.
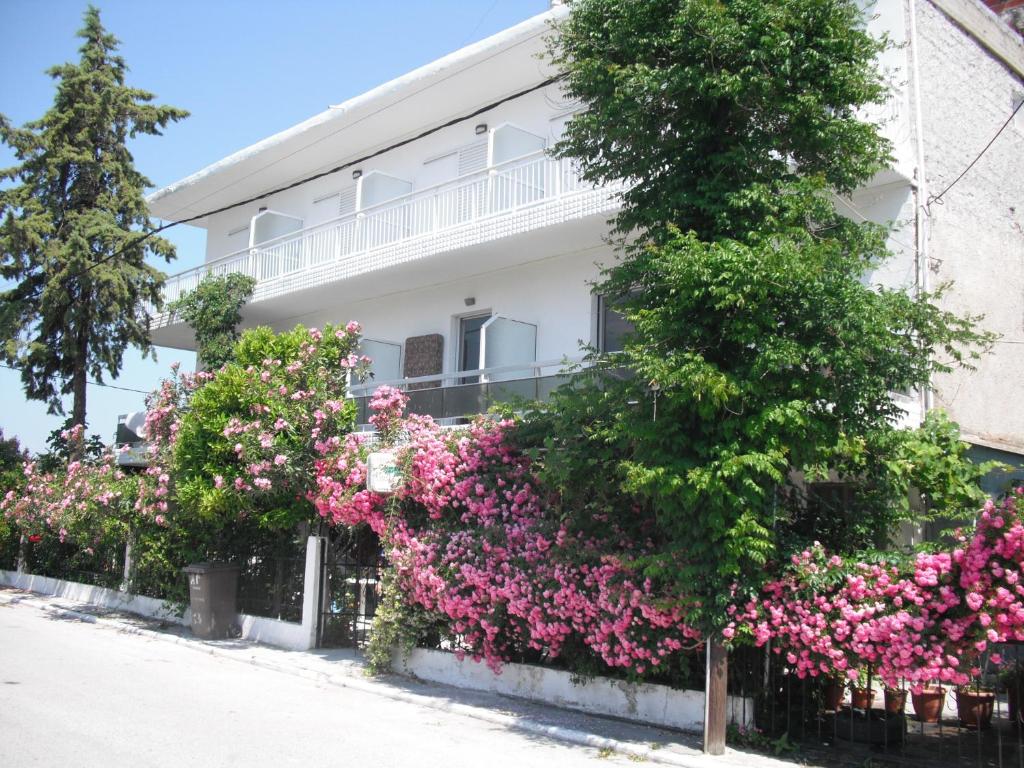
172 323 369 530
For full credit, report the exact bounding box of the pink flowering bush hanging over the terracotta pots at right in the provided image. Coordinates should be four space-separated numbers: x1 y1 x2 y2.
726 487 1024 686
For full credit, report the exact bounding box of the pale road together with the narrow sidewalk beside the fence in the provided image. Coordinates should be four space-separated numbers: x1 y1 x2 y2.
0 589 792 768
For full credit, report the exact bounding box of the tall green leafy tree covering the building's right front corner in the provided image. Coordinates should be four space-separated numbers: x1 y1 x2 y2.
524 0 988 628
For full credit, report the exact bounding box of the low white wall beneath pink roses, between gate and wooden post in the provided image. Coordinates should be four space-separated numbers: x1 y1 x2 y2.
393 648 754 732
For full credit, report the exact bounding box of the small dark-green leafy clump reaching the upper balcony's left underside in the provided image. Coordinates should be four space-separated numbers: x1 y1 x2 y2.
168 273 256 370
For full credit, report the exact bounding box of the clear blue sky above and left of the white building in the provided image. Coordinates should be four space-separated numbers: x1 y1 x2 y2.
0 0 549 451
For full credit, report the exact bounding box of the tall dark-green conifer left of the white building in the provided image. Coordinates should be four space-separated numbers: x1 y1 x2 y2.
0 6 187 438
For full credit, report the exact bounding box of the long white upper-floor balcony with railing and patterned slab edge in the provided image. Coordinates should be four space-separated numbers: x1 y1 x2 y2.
155 152 623 328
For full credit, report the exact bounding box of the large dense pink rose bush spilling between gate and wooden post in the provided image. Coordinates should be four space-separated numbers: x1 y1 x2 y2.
314 388 698 675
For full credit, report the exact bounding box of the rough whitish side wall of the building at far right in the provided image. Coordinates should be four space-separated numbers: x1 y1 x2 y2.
916 0 1024 452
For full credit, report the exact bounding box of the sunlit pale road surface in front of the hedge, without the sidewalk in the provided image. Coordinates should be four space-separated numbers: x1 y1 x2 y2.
0 604 630 768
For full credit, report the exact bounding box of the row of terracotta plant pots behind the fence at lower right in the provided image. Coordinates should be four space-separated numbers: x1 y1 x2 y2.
824 681 999 728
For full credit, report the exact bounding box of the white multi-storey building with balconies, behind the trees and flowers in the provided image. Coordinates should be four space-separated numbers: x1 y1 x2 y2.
150 0 1024 479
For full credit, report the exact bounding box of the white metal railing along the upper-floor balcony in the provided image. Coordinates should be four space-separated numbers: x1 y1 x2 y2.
164 152 606 302
